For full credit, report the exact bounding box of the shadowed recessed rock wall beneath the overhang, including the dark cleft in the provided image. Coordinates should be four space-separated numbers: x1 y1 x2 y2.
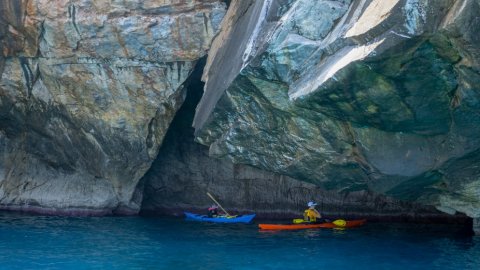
141 64 465 222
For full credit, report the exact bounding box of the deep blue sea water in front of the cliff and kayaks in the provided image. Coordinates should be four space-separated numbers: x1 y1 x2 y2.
0 214 480 270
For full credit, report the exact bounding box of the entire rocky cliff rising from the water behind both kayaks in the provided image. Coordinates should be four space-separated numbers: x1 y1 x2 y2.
0 0 480 229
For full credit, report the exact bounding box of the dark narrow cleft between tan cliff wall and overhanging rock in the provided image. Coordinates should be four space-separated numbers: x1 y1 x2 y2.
138 56 208 215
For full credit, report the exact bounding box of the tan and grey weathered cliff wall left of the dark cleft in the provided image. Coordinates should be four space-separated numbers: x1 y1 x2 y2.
0 0 225 214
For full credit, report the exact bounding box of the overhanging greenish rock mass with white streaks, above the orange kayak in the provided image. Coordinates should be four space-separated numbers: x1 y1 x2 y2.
194 0 480 218
